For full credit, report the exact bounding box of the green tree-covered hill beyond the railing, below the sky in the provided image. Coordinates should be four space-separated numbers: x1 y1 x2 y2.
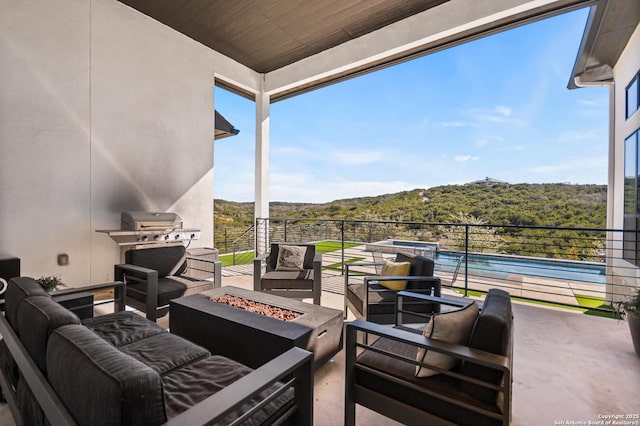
214 183 607 228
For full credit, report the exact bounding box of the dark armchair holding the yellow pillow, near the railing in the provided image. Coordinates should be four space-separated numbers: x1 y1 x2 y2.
344 253 441 324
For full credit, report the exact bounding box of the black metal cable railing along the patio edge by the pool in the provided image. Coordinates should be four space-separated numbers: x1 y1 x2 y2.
242 218 638 312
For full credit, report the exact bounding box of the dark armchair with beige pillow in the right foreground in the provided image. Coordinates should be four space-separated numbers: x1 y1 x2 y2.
345 289 513 426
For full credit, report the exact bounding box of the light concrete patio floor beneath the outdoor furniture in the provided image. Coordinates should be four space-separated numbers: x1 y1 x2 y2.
0 275 640 426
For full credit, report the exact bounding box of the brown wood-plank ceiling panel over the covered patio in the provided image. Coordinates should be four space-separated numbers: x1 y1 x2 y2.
120 0 449 73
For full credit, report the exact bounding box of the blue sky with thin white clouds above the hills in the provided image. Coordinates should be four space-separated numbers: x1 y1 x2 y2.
214 9 608 202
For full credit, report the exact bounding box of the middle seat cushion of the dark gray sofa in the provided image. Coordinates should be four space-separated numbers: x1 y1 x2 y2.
119 333 209 375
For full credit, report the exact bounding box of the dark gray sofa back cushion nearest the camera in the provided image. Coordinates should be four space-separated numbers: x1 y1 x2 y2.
47 325 167 426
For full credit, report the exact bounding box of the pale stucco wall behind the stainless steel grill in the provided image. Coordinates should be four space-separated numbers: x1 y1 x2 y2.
0 0 259 286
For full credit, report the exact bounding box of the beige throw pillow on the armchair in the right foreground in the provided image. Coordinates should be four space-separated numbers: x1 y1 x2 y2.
416 302 479 377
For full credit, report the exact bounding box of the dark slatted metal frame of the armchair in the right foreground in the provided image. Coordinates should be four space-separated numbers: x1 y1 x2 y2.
345 291 513 426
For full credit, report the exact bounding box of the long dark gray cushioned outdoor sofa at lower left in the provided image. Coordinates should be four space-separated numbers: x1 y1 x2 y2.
0 277 313 426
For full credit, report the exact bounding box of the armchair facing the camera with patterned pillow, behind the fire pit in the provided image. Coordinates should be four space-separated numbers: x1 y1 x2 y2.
253 243 322 305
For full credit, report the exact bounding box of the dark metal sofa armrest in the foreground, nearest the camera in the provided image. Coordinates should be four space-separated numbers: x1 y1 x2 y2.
167 347 313 426
